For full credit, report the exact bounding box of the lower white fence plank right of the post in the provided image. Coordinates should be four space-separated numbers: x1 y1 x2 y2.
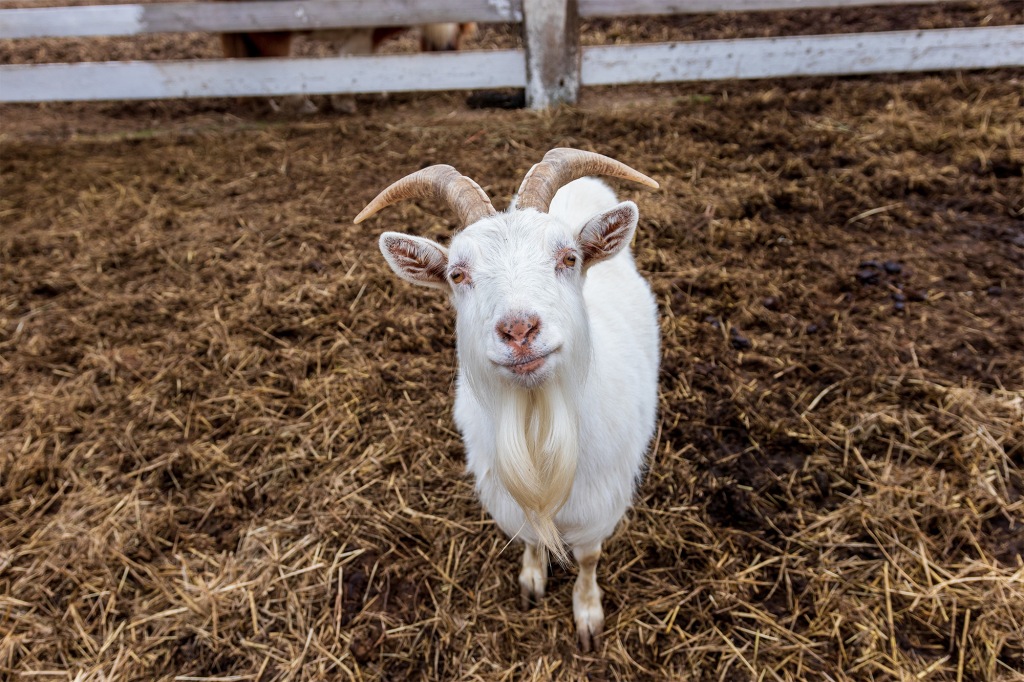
582 26 1024 86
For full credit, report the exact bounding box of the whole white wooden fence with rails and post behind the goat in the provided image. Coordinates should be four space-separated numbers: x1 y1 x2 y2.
0 0 1024 108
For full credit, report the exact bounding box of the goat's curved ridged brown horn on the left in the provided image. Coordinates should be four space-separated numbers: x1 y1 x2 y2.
353 164 497 227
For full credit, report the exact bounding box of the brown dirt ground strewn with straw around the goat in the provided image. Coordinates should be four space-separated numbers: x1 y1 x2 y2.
0 2 1024 681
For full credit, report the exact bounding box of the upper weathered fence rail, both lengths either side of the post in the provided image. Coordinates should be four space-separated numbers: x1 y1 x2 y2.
0 0 974 39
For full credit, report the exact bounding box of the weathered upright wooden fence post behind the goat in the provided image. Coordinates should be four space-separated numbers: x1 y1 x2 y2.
522 0 580 109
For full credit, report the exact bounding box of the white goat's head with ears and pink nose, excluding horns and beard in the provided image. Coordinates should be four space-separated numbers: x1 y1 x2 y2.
380 202 638 388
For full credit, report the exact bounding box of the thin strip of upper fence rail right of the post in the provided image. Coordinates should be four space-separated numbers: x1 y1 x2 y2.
580 0 963 17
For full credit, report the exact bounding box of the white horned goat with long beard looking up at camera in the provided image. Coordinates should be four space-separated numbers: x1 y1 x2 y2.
355 150 658 650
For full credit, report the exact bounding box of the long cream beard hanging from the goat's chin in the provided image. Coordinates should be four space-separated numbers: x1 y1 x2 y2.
494 377 580 563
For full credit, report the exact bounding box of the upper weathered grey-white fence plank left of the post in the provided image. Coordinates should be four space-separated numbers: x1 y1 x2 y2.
0 0 522 39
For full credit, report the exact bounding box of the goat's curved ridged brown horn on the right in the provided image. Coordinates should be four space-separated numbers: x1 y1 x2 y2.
516 147 658 213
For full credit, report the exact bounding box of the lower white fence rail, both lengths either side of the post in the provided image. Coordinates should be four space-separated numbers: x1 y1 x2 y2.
0 26 1024 102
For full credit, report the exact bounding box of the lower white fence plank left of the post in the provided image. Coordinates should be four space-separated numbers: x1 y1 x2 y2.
0 50 526 102
